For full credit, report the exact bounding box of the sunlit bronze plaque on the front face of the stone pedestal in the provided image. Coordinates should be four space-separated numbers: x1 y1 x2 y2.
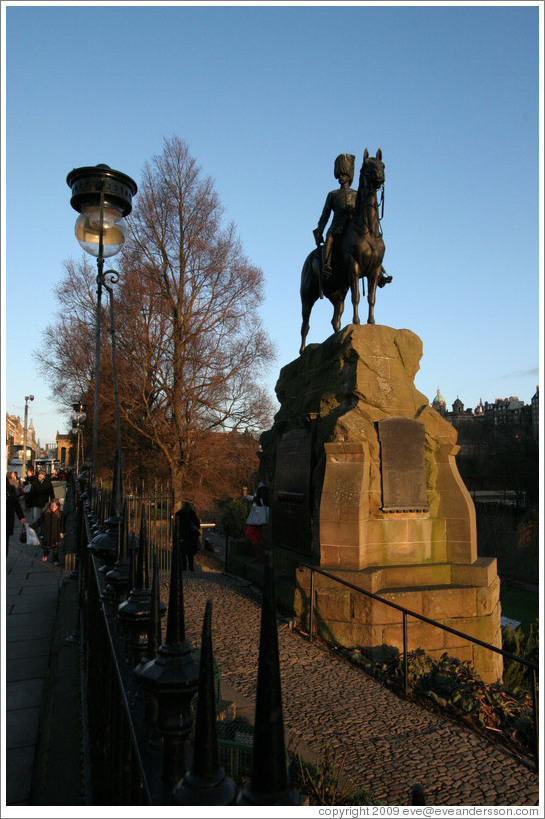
378 418 428 512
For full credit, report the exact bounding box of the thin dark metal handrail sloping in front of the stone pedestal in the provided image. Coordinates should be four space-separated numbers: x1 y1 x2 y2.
299 563 539 769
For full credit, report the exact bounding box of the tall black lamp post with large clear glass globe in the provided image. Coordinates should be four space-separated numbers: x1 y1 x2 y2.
66 165 138 477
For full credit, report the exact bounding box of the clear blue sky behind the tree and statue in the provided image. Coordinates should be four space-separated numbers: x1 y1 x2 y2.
2 2 543 443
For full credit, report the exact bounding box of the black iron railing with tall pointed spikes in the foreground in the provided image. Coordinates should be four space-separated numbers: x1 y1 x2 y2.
76 474 299 806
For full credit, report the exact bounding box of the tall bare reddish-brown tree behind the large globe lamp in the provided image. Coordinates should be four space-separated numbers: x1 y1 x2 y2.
37 137 274 502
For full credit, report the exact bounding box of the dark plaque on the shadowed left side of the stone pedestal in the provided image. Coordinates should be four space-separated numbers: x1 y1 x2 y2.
271 428 312 554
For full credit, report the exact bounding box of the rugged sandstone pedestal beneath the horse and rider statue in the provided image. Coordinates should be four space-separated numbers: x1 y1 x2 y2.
260 325 502 681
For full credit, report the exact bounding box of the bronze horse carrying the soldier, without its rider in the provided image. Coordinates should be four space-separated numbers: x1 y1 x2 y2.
299 148 391 353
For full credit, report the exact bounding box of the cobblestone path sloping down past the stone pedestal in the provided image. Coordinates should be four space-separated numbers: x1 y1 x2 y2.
173 572 539 806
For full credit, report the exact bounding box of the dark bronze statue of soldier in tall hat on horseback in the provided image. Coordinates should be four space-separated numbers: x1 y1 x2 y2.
299 148 392 353
